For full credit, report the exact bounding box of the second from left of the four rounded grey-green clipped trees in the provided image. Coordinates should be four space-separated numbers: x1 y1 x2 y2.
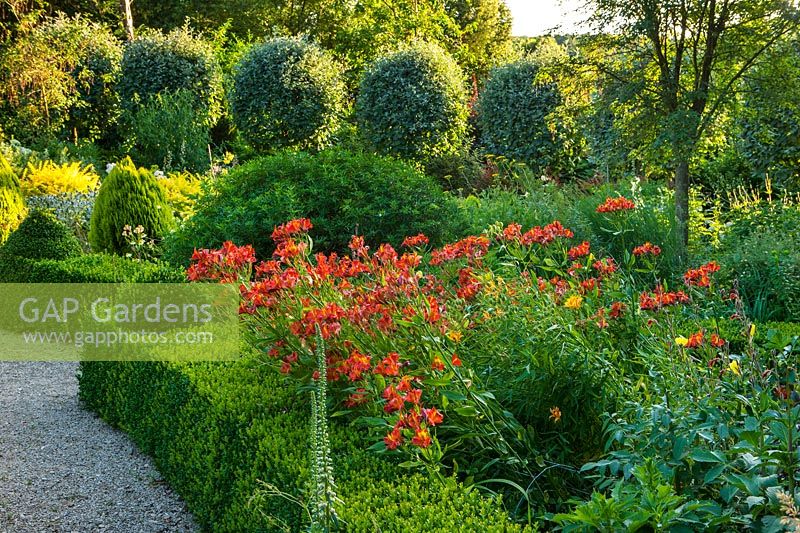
231 37 345 150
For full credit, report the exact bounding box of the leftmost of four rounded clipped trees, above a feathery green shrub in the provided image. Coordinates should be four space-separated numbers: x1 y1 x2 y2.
117 27 222 127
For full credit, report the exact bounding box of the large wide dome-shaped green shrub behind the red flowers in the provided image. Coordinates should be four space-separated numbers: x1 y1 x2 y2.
165 149 459 264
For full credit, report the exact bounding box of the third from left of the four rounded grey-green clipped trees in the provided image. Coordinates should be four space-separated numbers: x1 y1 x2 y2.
356 44 468 161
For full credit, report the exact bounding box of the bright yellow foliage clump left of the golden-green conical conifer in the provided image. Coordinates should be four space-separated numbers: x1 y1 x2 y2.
20 161 99 197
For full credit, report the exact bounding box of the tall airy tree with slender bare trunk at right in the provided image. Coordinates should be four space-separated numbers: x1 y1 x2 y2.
589 0 798 257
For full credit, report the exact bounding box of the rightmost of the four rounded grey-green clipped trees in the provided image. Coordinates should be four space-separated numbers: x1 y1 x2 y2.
477 59 561 170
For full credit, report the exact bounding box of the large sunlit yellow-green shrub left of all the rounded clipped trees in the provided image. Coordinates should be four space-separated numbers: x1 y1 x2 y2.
0 16 122 141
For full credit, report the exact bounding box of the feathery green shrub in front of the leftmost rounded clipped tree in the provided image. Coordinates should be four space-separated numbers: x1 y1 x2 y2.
128 89 211 172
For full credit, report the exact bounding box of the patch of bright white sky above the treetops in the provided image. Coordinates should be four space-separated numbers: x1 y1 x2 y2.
506 0 586 36
